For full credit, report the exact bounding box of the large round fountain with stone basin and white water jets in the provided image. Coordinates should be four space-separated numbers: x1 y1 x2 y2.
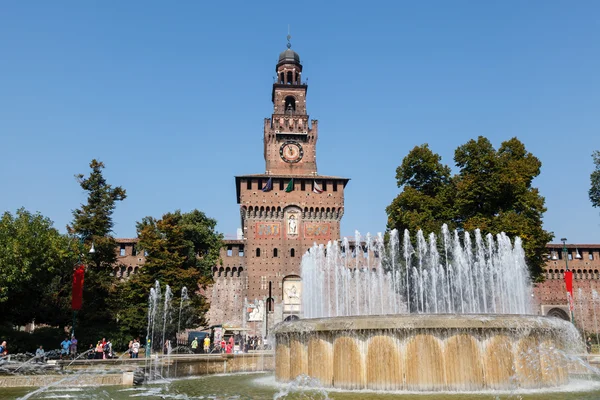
274 225 583 391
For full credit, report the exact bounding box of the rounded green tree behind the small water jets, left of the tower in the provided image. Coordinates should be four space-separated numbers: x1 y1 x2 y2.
113 210 222 337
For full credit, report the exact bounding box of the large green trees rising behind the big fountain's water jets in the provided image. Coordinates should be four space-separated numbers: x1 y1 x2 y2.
386 136 553 277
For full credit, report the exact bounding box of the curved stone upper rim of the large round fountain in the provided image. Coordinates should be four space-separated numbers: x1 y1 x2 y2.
272 314 571 335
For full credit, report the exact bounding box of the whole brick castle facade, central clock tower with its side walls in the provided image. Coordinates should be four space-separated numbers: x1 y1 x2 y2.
114 43 600 335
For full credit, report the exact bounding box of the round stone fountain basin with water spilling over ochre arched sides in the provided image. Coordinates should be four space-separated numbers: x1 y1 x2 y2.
274 314 581 391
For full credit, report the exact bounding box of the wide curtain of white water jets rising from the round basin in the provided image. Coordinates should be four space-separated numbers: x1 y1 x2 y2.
301 225 532 318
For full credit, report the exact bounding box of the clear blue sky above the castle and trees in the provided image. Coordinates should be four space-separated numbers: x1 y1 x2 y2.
0 1 600 243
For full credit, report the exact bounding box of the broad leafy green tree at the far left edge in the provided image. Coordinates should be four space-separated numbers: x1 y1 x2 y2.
0 208 76 326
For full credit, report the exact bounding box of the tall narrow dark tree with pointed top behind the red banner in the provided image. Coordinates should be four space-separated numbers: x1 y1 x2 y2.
67 160 127 337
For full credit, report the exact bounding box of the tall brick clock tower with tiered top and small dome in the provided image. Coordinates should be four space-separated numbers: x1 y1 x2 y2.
235 36 348 331
